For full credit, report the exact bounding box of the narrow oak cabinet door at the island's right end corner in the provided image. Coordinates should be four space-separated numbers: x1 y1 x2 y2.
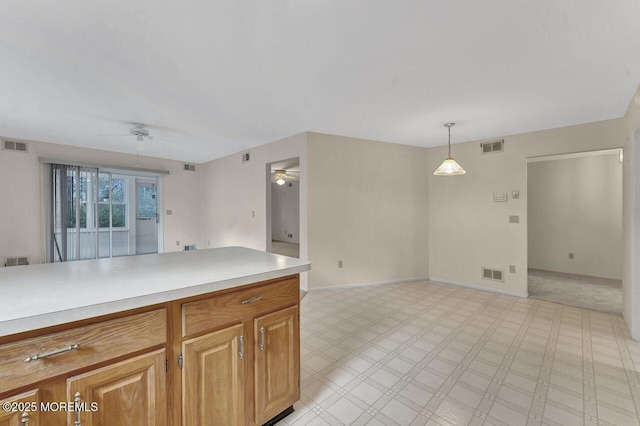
254 306 300 424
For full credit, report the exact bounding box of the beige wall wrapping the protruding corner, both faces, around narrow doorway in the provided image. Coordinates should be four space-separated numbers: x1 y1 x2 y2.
203 133 428 288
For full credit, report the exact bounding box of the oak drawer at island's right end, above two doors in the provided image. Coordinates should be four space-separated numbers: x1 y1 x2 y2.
182 276 300 336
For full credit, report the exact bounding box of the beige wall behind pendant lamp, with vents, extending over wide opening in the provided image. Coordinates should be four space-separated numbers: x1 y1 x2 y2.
427 119 625 296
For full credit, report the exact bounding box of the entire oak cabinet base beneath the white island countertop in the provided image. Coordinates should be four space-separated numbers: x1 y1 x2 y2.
0 275 300 426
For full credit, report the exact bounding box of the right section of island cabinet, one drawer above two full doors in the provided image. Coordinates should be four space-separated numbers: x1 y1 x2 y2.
180 276 300 426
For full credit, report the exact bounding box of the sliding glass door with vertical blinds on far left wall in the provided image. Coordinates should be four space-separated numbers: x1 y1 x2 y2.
47 164 160 262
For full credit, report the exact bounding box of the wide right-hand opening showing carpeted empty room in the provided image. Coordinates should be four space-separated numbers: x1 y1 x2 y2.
527 149 623 313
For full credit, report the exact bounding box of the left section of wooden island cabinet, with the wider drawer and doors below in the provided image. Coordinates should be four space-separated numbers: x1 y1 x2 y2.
0 308 167 426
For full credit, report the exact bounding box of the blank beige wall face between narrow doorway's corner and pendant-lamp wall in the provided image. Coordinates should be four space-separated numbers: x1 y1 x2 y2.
309 133 429 288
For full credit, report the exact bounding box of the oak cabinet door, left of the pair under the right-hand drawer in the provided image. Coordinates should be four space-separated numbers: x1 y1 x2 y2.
182 324 246 426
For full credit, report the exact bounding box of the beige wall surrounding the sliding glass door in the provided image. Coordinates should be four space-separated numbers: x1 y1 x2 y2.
0 138 202 263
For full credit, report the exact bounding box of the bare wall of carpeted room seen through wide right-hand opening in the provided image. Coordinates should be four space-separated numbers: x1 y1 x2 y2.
527 153 623 280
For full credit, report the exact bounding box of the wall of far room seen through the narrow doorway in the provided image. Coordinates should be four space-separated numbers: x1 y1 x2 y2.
271 181 300 244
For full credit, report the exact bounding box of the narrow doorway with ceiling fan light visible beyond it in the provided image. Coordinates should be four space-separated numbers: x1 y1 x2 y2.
267 157 300 258
